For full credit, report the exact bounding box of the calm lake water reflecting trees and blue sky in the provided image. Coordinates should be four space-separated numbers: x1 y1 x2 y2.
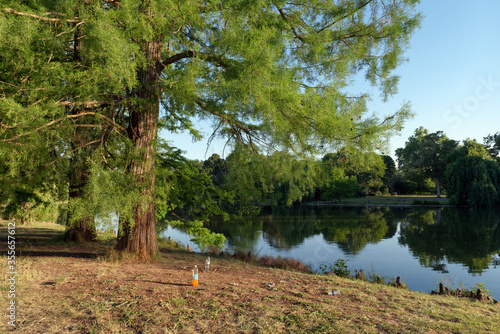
163 206 500 298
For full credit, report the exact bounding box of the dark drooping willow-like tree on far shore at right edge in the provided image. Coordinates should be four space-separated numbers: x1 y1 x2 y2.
446 140 500 208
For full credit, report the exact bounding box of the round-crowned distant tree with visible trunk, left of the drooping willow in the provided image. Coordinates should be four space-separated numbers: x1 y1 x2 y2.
396 127 458 198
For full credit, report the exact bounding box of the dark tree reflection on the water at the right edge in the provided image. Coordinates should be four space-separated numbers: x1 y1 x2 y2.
399 208 500 274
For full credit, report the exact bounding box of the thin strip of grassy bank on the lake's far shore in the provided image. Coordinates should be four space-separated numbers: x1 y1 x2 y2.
309 195 449 206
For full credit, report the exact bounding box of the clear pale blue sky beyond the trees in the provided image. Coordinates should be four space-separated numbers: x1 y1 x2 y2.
160 0 500 160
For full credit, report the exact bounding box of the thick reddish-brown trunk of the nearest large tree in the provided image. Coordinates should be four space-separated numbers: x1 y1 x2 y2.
117 41 163 260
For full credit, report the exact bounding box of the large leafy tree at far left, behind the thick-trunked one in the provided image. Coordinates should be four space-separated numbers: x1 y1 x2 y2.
0 1 135 241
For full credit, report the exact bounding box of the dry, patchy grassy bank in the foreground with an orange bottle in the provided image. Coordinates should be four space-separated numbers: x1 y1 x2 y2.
0 220 500 333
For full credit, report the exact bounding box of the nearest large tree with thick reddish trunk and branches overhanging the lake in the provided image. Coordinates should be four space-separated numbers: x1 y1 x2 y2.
0 0 420 258
